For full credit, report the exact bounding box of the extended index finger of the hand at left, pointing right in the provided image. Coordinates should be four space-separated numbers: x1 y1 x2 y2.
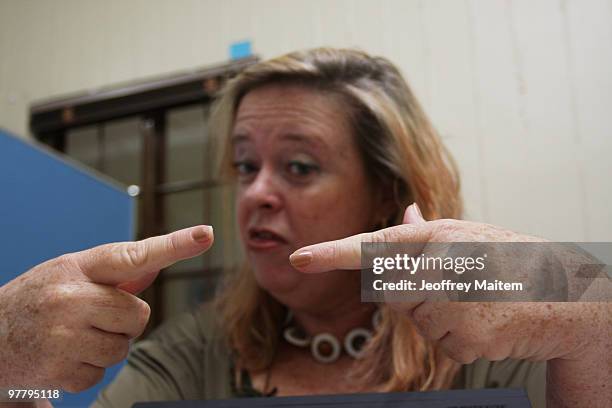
74 225 213 293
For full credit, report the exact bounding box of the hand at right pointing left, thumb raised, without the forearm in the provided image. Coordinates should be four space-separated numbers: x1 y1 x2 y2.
291 205 612 363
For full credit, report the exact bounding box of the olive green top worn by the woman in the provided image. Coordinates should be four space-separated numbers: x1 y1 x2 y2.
93 305 546 408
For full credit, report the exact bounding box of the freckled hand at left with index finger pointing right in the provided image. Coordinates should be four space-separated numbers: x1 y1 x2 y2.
0 226 213 392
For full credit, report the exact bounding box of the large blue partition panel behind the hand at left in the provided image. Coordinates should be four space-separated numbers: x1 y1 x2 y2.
0 129 134 407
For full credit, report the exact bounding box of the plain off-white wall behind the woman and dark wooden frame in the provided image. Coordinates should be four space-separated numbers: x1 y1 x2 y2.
0 0 612 241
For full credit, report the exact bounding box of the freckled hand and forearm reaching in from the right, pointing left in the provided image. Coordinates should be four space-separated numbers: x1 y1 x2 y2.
296 215 612 408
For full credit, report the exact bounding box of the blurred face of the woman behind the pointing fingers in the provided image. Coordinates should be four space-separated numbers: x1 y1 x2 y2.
232 85 383 308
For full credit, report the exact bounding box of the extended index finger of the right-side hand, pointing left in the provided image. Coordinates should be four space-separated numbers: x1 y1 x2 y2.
289 223 428 273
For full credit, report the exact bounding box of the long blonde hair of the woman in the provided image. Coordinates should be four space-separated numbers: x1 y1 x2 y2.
211 48 462 391
